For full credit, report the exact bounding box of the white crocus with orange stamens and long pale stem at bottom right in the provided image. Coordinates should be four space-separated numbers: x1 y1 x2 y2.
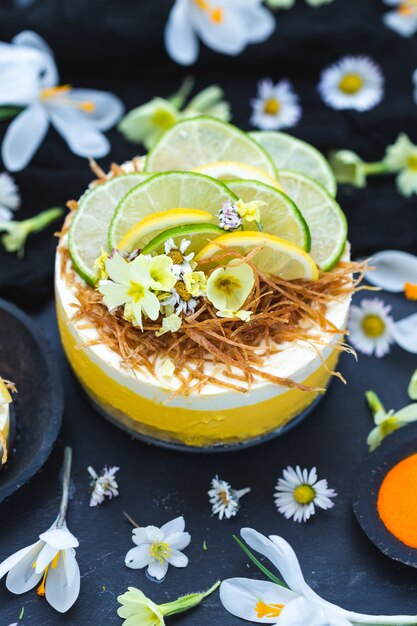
220 528 417 626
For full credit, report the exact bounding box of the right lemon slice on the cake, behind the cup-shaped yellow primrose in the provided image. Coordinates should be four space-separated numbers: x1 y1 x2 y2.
195 231 318 280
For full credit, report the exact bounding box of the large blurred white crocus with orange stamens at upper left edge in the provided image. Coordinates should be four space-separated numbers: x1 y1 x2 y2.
0 31 124 172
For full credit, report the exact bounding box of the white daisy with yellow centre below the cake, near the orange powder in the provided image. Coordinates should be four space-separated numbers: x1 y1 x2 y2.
274 465 337 522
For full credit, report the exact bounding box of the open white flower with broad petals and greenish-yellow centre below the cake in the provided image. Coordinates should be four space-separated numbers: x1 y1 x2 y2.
125 517 191 580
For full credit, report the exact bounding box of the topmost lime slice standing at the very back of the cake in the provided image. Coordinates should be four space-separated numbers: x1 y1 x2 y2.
145 116 276 178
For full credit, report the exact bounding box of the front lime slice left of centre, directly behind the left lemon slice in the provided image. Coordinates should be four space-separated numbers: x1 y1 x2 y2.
109 172 237 249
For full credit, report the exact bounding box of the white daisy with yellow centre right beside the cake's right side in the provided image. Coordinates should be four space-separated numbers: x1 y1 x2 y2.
348 298 395 358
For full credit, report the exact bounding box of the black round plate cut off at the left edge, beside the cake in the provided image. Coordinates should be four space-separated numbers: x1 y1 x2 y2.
0 299 64 502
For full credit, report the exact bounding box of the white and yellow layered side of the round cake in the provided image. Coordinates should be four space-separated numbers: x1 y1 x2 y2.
56 241 350 449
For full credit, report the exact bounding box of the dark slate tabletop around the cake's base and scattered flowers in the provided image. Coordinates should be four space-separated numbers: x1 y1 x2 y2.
0 288 417 626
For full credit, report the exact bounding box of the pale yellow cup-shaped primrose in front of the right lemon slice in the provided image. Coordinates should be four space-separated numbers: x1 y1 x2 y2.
207 262 255 311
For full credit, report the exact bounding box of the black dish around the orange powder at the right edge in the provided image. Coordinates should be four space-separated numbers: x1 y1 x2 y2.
353 424 417 567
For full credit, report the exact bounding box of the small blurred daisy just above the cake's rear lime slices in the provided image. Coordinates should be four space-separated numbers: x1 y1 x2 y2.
250 78 302 130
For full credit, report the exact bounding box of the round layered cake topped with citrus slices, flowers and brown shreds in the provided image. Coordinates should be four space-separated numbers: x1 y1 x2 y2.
56 120 356 450
